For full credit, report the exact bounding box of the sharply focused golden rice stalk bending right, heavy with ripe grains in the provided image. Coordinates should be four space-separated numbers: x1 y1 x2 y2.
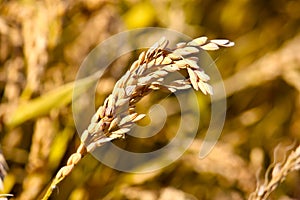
43 37 234 200
